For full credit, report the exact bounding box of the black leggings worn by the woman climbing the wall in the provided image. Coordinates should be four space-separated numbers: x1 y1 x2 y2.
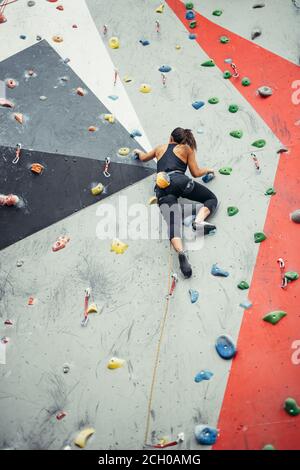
155 173 218 240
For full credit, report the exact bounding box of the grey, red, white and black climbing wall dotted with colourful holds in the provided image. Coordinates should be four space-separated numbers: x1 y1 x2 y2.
0 0 300 450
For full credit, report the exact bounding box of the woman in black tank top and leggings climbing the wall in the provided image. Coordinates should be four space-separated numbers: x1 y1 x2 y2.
134 127 218 278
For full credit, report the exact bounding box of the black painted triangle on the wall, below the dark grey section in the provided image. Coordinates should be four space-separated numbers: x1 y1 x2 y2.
0 146 154 249
